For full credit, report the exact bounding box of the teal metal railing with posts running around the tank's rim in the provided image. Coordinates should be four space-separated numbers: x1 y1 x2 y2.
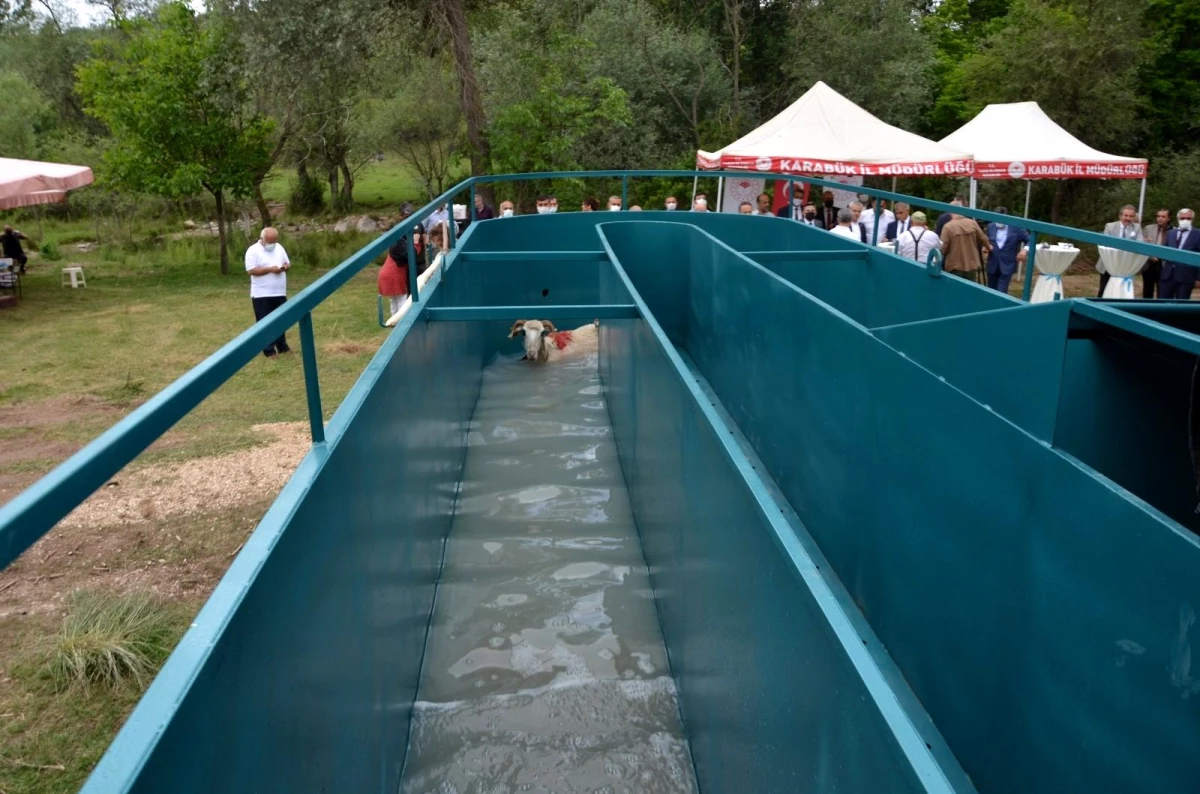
0 170 1200 569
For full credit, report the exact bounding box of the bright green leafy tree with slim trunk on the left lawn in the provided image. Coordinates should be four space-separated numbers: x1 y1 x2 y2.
79 2 271 273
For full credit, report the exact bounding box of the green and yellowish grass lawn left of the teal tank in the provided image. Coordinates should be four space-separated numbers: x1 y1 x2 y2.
0 223 385 794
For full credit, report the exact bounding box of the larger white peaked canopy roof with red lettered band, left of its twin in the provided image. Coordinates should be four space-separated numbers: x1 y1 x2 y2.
696 82 973 176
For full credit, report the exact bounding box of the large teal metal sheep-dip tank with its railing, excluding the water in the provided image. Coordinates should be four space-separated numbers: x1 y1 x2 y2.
0 172 1200 794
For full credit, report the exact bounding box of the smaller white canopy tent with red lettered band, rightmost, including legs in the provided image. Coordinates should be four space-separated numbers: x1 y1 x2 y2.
941 102 1147 217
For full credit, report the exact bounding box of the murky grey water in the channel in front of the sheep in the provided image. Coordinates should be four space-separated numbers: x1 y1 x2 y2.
401 356 696 794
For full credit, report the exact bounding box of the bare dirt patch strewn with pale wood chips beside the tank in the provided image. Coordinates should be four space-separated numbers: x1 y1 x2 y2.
0 422 308 619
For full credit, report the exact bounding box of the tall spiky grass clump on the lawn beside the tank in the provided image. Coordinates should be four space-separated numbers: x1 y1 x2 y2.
49 590 179 691
